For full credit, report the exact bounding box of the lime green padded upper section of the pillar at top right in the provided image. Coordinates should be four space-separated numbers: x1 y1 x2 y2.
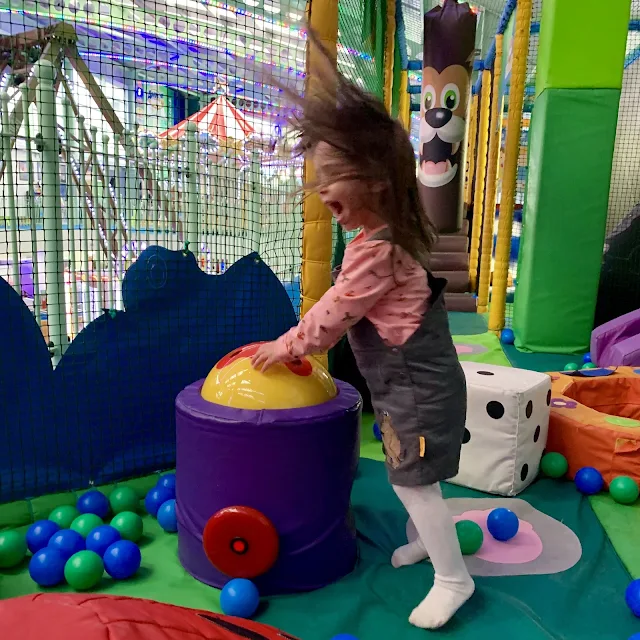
536 0 631 95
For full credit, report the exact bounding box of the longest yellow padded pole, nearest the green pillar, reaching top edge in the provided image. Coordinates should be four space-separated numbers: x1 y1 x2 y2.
489 0 532 332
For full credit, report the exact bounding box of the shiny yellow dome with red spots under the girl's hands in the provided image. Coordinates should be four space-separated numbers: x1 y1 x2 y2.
200 343 338 409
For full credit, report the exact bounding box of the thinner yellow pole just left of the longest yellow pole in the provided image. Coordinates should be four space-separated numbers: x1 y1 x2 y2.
469 69 491 291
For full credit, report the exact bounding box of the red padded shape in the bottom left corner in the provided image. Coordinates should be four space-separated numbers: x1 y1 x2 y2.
0 593 296 640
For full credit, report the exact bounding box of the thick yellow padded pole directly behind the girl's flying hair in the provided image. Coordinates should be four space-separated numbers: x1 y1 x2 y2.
300 0 338 365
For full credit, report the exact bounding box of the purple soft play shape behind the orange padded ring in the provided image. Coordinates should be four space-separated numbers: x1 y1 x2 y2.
591 309 640 367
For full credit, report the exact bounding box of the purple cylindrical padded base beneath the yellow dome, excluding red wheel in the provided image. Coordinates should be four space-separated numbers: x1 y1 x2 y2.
176 380 361 595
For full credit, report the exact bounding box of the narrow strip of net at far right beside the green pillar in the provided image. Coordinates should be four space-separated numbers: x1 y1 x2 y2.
596 21 640 325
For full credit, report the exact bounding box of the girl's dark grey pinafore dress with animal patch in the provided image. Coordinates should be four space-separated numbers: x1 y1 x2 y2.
336 230 467 486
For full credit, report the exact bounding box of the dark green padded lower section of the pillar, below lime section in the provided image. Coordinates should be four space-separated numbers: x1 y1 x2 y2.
513 88 620 353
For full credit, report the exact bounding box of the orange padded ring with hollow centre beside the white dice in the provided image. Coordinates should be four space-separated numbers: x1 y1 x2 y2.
547 367 640 484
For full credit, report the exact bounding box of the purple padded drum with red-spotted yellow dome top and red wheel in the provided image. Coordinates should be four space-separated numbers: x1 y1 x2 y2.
176 345 362 595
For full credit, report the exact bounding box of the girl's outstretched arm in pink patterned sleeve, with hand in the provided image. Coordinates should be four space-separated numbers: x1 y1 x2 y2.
253 241 395 371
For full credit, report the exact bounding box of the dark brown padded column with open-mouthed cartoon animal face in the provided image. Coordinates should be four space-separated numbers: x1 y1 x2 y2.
418 0 476 232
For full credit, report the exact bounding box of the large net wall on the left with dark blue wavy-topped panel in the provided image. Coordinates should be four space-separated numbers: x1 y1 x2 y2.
0 0 310 502
